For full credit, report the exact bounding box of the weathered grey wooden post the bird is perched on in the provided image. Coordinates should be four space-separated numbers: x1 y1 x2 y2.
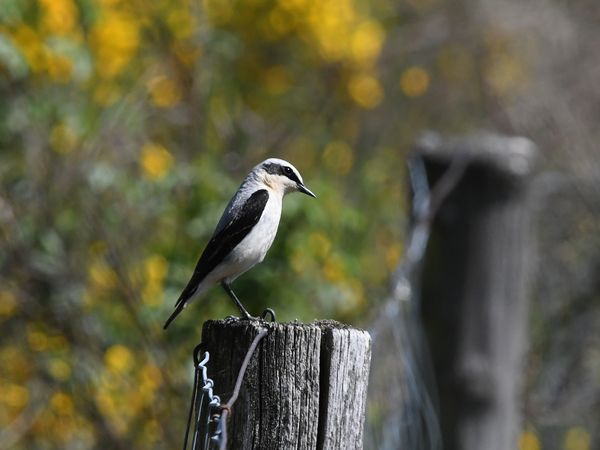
202 320 371 450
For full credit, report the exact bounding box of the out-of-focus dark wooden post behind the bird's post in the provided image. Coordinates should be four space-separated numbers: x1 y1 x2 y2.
416 134 536 450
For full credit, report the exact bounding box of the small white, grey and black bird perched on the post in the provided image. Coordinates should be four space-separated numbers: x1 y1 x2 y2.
163 158 317 330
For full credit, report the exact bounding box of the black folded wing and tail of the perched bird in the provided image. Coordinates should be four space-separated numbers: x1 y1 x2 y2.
164 189 269 329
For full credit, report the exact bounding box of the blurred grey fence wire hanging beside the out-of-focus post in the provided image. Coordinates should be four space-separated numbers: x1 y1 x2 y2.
366 156 468 450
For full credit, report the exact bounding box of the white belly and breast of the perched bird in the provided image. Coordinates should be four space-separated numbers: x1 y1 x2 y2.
220 195 281 281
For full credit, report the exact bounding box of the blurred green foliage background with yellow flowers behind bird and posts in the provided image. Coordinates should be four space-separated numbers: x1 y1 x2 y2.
0 0 600 450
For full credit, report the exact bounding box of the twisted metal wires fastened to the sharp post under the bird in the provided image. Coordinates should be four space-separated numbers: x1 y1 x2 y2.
183 329 268 450
